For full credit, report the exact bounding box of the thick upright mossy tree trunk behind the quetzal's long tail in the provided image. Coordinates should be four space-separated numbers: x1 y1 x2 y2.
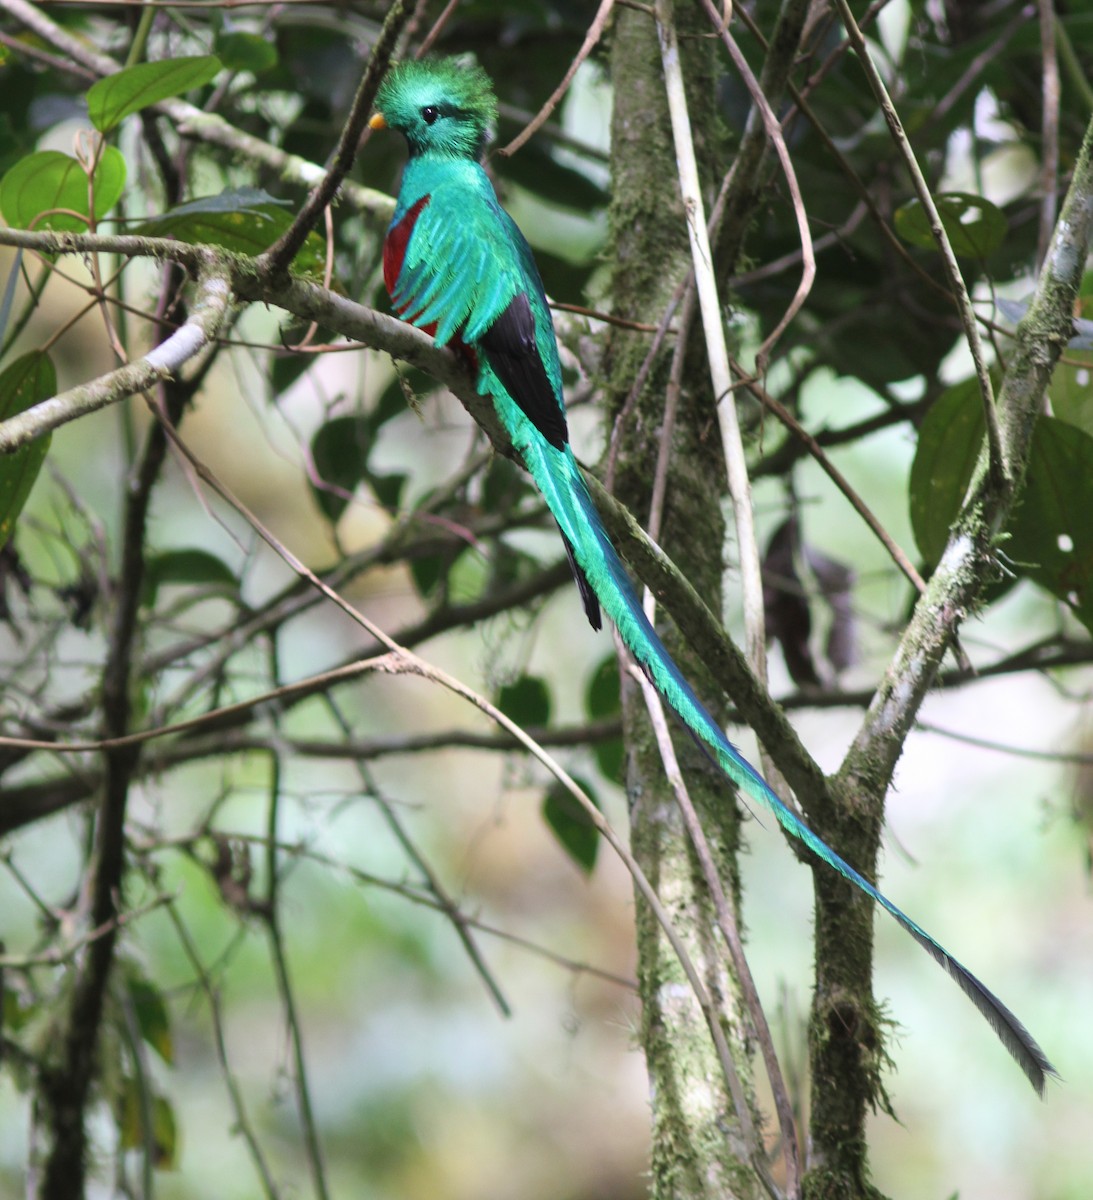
605 8 758 1200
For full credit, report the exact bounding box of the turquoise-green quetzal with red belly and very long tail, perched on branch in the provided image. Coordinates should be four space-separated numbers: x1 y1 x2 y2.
370 59 1055 1094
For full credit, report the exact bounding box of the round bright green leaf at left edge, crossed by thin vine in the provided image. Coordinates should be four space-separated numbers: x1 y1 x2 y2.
0 146 126 233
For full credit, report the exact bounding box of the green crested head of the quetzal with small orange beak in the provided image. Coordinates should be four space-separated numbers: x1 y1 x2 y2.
370 58 497 158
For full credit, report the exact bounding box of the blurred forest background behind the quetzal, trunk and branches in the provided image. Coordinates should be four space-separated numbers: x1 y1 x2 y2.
0 0 1093 1200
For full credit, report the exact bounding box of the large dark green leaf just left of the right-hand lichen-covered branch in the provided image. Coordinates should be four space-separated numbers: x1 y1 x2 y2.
911 379 985 568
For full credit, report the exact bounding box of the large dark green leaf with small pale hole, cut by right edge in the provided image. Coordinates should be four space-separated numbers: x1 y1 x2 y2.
1003 416 1093 632
